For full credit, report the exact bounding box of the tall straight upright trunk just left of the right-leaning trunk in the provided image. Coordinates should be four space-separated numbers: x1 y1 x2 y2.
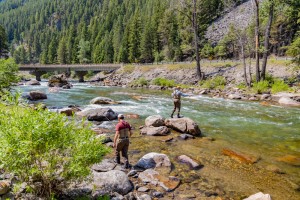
255 0 260 82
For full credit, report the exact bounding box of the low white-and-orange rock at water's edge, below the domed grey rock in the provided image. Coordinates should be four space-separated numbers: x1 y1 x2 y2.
139 169 180 192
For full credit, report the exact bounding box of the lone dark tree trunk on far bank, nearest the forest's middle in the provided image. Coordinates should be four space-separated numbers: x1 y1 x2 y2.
192 0 203 80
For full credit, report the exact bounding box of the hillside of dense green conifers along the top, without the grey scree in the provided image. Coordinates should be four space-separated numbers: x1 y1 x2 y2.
0 0 300 64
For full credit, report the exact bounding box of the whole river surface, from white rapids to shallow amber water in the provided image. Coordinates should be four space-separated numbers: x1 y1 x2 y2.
17 82 300 199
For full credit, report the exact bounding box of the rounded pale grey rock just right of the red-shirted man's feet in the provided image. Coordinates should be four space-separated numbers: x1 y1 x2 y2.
135 152 171 169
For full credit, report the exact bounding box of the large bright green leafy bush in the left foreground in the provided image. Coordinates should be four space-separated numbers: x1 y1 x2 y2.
0 104 109 198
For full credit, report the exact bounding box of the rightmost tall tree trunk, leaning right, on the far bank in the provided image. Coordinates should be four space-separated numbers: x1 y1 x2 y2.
261 0 274 80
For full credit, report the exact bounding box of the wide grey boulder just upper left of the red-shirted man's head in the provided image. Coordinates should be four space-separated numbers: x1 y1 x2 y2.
76 108 118 121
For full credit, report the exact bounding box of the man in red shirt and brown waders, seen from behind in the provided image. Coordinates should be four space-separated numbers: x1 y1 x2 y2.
114 114 132 169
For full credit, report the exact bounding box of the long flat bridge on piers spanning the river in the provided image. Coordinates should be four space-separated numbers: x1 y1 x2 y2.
19 64 122 82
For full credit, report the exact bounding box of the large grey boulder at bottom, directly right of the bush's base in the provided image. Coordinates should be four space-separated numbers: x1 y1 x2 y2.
93 170 133 195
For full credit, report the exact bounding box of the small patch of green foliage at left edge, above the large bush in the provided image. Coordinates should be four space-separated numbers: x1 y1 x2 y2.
0 58 19 92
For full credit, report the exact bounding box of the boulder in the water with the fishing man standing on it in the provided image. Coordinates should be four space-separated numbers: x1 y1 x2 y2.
165 117 201 136
